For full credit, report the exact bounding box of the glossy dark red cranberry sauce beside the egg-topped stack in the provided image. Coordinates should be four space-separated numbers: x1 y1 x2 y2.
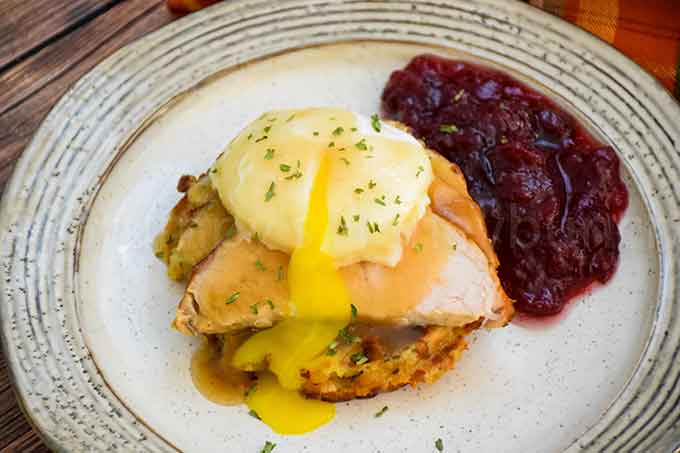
382 55 628 316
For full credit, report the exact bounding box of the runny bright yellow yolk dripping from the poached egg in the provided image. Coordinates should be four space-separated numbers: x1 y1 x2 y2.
233 158 351 434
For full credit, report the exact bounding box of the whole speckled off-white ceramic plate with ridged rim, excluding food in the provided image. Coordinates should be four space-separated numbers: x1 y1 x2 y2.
0 0 680 453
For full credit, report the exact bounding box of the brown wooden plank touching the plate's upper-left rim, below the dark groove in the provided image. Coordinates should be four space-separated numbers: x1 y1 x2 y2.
0 0 175 193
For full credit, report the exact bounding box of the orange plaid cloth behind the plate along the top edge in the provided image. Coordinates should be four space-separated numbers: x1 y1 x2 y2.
166 0 680 99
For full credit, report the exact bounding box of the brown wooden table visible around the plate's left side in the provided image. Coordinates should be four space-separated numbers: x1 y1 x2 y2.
0 0 176 453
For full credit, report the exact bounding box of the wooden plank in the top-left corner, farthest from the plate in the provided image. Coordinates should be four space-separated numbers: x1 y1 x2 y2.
0 0 120 69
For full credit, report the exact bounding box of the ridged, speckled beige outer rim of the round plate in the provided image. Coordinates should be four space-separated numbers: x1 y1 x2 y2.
0 0 680 451
